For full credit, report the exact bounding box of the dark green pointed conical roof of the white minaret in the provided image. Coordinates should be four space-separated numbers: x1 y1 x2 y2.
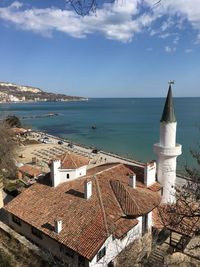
160 84 176 122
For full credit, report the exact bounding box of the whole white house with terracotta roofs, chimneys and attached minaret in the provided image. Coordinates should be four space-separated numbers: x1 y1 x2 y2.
0 85 181 267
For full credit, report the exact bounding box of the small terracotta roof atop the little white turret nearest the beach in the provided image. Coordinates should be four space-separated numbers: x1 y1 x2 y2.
51 152 89 169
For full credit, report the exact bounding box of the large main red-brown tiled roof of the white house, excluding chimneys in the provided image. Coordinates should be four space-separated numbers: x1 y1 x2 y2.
5 164 160 260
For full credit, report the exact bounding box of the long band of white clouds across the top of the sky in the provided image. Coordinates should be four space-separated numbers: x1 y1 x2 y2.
0 0 200 43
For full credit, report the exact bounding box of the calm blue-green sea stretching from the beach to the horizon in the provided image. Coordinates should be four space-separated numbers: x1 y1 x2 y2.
0 97 200 172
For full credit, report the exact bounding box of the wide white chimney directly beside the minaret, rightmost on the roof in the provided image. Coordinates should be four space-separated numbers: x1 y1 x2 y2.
144 161 156 186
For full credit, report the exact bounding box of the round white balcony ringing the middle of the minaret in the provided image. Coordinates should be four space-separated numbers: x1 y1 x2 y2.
154 143 182 157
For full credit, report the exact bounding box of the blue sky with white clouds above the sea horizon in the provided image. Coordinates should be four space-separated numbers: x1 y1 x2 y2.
0 0 200 97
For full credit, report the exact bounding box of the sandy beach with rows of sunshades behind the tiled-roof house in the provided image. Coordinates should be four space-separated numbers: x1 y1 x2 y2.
17 132 143 172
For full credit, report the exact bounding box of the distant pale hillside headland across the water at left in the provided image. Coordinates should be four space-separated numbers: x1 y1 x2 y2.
0 82 87 103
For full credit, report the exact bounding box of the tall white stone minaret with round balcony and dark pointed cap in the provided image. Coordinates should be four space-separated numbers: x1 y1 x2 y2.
154 81 182 204
